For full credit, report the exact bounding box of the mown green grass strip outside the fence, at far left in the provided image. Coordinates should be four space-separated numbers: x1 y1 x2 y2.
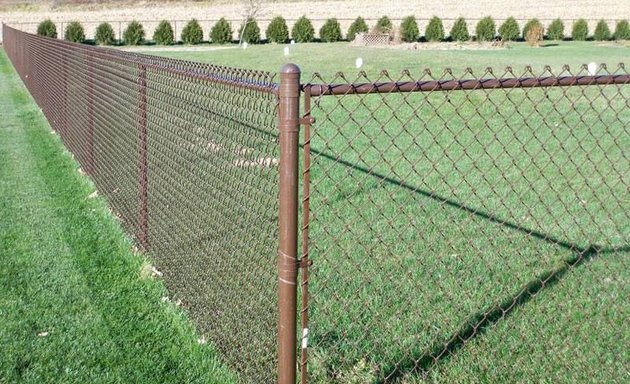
0 51 234 384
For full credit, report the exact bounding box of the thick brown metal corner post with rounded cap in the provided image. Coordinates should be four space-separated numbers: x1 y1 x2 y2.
278 64 300 384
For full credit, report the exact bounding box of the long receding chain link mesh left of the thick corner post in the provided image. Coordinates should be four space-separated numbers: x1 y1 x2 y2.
4 26 278 383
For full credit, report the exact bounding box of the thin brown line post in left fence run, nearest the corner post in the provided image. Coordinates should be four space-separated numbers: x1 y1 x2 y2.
138 64 149 250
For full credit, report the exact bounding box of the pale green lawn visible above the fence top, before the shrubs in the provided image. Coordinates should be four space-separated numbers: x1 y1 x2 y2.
139 41 630 82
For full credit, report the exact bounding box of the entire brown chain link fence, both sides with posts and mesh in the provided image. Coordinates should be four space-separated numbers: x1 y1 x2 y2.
3 26 630 383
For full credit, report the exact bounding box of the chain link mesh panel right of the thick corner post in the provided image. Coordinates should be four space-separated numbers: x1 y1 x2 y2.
302 65 630 383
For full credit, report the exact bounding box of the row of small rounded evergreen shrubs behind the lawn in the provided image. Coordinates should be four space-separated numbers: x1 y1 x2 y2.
37 16 630 45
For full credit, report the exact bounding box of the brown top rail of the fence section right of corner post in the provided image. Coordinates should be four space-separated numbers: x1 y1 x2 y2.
302 74 630 96
